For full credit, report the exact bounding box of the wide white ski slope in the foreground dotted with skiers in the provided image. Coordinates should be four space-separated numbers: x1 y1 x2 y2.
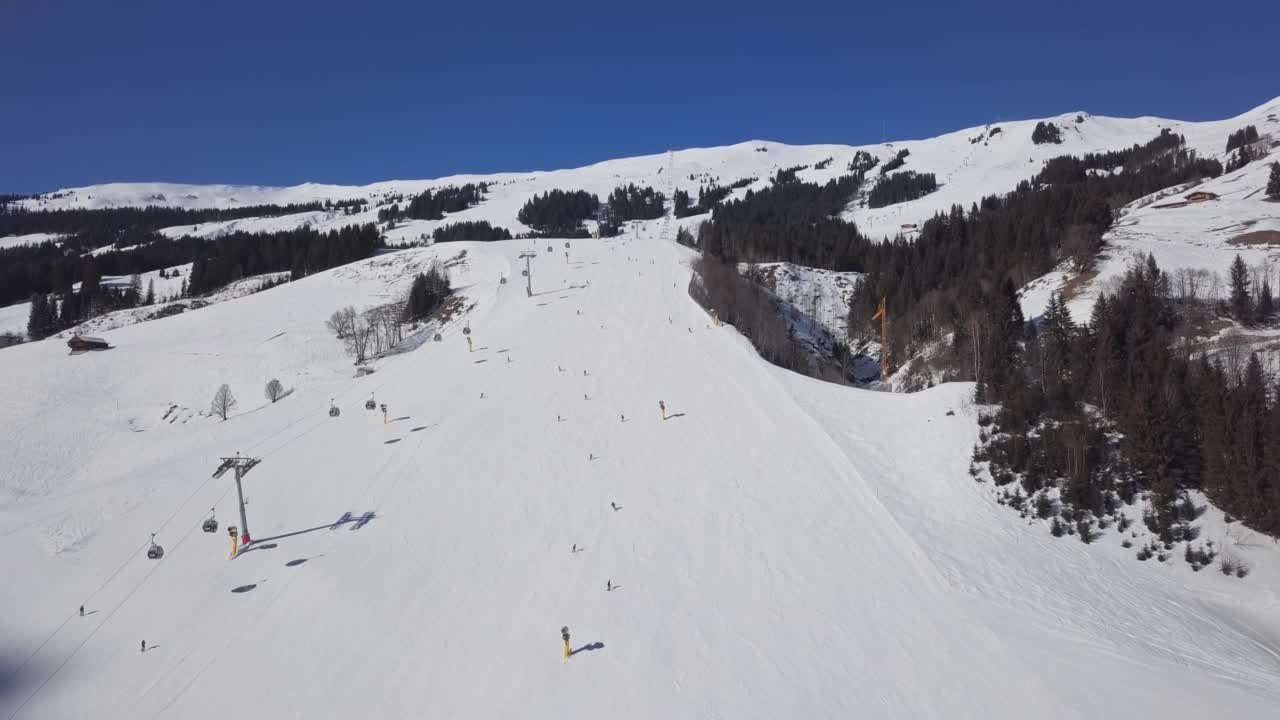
0 215 1280 720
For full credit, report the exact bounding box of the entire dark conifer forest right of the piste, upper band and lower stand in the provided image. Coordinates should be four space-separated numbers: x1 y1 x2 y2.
694 124 1280 538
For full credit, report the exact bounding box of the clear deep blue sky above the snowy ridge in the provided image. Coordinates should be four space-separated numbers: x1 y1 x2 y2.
0 0 1280 192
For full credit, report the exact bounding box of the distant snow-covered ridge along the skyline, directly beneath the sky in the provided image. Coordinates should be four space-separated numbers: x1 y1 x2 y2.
12 97 1280 249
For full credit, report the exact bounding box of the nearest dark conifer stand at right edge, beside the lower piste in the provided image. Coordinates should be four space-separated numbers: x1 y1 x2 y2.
975 258 1280 543
